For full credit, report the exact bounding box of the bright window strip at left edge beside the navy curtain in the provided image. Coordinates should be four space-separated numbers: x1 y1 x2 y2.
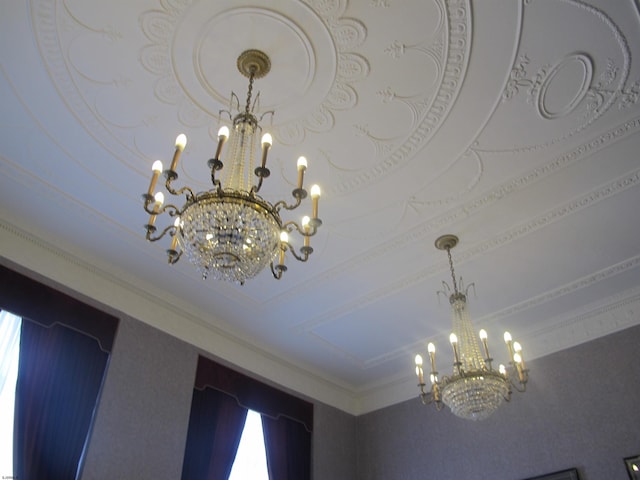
0 311 21 478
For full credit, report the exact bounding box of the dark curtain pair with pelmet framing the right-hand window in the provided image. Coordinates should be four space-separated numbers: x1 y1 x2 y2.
182 357 313 480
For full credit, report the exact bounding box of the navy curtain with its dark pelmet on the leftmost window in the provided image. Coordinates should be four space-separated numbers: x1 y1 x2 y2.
0 266 118 480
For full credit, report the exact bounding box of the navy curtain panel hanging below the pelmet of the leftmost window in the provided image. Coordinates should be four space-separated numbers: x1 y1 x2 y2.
14 320 109 480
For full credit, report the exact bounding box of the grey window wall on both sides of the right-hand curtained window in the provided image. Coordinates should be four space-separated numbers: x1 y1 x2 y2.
81 318 356 480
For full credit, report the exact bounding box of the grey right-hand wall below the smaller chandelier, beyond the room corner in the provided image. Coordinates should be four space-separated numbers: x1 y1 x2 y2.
357 327 640 480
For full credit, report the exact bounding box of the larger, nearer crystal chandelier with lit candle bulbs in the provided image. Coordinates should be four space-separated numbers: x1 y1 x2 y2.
143 50 322 284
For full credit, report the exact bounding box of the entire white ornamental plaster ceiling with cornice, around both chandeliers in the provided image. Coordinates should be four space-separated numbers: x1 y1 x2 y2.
0 0 640 413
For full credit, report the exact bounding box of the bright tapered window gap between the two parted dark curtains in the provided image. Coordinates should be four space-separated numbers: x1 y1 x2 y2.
229 410 269 480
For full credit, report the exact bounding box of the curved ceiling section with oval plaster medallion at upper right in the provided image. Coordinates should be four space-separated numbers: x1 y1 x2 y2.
481 0 631 152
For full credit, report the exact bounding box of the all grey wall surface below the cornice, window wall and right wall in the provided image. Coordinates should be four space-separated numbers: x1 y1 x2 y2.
77 318 640 480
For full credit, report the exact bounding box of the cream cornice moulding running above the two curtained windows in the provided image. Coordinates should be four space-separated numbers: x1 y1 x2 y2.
0 220 357 414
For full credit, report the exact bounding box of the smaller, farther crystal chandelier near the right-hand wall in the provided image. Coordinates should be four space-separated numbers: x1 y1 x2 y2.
415 235 529 420
